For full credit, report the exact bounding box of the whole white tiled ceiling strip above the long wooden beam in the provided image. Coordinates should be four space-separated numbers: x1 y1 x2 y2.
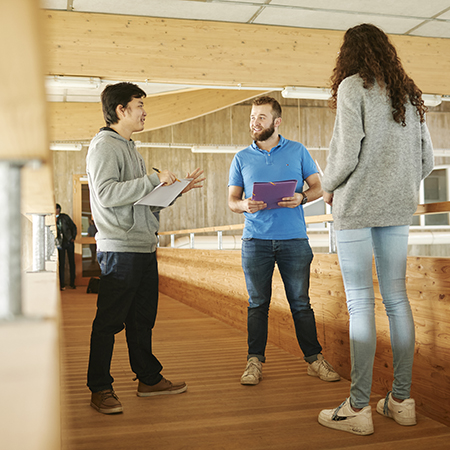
41 0 450 38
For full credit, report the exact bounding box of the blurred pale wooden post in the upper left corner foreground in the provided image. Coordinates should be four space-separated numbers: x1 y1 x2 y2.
0 0 50 161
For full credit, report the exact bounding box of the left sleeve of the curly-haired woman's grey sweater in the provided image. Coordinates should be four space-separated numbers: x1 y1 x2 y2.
322 77 365 193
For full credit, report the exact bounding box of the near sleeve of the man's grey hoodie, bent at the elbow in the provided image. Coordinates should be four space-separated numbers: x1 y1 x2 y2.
88 143 159 208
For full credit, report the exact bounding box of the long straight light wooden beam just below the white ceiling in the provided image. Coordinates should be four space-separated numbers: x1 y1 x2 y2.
43 11 450 94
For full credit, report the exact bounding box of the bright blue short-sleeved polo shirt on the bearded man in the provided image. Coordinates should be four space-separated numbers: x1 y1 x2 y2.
228 135 317 240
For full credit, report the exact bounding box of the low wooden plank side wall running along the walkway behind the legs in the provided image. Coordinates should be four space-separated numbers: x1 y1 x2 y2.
158 248 450 425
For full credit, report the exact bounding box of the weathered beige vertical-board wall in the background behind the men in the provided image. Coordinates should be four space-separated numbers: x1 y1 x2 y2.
53 92 450 239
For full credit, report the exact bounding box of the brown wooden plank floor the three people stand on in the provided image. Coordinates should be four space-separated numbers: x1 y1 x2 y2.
61 287 450 450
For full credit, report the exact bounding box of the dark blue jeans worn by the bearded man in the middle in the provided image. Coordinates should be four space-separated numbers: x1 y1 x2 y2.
242 239 322 362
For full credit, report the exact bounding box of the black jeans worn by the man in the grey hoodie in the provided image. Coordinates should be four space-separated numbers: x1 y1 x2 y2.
87 252 162 392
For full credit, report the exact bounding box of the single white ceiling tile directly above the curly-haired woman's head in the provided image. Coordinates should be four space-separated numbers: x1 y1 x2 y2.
253 9 422 34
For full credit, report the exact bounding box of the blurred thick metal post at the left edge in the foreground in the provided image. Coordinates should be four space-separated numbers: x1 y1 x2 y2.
0 161 22 320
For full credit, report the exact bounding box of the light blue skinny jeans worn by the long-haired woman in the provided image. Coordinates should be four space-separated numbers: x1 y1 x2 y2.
336 226 415 408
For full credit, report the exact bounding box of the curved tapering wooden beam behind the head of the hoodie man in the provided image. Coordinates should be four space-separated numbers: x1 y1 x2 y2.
49 89 265 142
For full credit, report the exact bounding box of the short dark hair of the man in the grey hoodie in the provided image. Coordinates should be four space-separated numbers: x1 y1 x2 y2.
101 82 147 126
